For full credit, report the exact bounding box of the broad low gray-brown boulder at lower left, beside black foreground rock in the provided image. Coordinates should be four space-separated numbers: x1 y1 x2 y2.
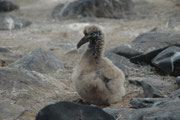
0 67 72 120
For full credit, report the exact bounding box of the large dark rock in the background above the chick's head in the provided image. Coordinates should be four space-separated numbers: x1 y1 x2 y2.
52 0 133 19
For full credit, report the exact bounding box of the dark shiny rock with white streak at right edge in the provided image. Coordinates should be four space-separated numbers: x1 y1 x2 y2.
152 46 180 76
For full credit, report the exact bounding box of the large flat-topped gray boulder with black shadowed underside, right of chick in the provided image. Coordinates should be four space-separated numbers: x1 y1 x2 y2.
130 32 180 64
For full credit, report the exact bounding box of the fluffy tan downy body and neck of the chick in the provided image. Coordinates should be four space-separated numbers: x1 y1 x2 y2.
72 25 125 104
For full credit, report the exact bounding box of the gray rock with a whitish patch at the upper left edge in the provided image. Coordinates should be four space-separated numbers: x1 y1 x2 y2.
0 14 31 30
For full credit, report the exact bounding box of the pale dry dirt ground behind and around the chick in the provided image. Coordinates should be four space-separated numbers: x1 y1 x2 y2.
0 0 180 119
